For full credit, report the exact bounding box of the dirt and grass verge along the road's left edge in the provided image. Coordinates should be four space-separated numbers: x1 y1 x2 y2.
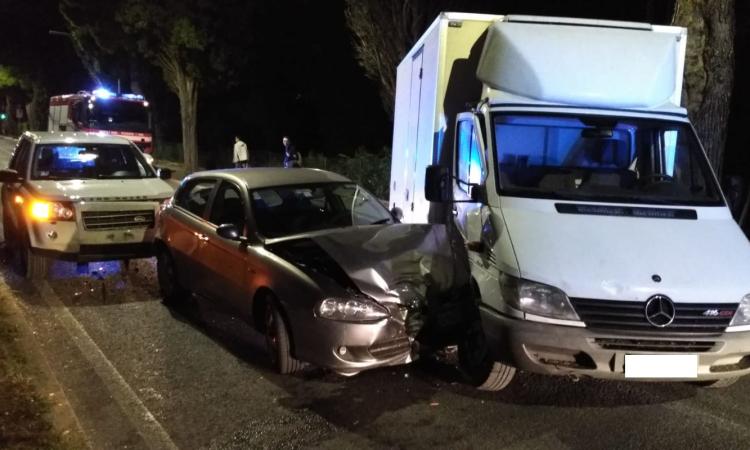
0 280 89 449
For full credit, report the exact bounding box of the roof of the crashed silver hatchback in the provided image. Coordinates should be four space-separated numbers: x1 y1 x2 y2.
185 167 352 189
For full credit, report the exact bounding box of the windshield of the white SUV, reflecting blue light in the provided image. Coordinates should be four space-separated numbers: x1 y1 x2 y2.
32 144 156 180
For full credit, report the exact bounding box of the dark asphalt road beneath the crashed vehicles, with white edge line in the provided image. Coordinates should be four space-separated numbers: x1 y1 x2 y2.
0 139 750 449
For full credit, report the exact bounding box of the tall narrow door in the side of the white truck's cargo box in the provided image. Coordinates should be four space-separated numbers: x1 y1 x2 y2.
402 47 424 222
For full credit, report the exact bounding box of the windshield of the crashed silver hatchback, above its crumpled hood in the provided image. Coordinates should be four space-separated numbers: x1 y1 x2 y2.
251 183 394 238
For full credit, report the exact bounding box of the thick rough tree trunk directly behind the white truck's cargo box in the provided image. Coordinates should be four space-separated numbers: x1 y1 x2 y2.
672 0 735 175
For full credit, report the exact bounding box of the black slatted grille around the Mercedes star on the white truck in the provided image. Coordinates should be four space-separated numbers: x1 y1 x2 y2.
570 298 737 334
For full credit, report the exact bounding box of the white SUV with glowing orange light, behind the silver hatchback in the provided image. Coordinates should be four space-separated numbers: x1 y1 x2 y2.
0 132 174 278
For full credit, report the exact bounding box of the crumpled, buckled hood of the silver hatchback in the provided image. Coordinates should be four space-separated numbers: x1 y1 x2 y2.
266 224 462 303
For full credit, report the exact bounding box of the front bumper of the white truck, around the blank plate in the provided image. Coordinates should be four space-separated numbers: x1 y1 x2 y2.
481 308 750 381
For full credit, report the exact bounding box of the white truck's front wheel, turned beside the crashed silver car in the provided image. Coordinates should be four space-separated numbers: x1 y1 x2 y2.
458 319 516 391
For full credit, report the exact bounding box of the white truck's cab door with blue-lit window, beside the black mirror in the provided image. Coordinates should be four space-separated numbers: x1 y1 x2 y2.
453 113 486 241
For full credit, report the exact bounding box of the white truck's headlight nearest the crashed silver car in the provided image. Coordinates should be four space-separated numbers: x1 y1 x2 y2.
501 275 580 320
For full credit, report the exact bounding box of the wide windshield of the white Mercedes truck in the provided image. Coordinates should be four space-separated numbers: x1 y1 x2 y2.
493 114 723 206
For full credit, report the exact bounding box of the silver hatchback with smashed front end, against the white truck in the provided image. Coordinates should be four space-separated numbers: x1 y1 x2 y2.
156 168 453 375
